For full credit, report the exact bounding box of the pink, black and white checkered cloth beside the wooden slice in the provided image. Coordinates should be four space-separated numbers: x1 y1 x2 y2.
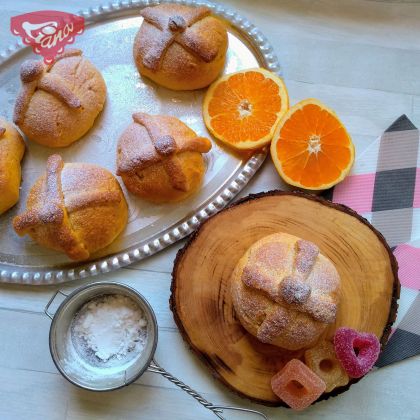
326 115 420 367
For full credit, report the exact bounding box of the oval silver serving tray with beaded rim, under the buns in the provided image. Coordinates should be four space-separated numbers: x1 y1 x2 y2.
0 0 280 284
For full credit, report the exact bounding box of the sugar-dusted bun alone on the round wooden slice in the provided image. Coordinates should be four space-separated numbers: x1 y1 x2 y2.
231 233 340 350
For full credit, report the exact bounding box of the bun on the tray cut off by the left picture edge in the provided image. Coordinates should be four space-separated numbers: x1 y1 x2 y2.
0 117 25 214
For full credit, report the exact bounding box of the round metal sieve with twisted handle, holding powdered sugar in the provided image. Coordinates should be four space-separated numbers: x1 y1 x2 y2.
44 282 267 420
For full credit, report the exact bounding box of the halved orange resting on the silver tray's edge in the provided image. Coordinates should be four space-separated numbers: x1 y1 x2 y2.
203 68 289 150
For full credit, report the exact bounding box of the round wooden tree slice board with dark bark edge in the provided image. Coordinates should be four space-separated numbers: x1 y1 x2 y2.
170 191 400 405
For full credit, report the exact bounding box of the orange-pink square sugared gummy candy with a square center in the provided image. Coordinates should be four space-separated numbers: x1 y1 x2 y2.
271 359 325 410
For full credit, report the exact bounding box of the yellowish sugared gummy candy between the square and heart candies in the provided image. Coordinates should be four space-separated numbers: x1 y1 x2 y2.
305 341 349 392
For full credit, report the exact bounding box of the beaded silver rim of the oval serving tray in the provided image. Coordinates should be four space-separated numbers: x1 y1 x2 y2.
0 0 281 285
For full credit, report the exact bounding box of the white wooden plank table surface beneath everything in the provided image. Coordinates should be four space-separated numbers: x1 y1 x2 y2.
0 0 420 420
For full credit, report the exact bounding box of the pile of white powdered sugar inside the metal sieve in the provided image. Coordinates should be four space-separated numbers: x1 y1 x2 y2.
71 294 147 364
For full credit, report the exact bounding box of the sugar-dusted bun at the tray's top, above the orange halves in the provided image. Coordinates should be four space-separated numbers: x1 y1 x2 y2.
133 4 228 90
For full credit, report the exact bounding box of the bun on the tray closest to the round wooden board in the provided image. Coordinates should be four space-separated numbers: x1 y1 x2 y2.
117 113 211 202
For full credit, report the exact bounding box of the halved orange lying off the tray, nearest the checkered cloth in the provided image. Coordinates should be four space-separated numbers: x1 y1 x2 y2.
271 99 354 190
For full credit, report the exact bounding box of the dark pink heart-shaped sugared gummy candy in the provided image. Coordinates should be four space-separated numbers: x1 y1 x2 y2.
334 327 381 378
